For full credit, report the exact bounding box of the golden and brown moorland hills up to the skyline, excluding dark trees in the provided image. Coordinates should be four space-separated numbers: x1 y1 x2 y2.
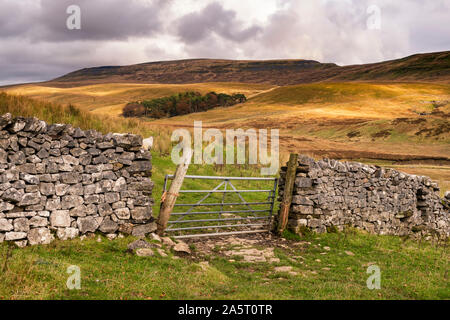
3 51 450 179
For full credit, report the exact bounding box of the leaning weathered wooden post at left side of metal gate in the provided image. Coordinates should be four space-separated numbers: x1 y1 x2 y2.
156 149 192 235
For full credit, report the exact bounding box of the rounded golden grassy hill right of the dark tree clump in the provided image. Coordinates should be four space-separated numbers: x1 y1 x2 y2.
152 83 450 154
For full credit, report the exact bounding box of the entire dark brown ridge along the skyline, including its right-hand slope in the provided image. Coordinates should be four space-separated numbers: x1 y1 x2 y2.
47 51 450 87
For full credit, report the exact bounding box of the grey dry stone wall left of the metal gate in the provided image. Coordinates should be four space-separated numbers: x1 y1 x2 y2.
0 114 156 246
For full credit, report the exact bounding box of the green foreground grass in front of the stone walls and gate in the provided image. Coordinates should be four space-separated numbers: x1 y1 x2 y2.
0 228 450 300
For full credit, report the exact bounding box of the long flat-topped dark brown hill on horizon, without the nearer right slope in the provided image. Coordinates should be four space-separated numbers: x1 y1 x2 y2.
50 59 336 86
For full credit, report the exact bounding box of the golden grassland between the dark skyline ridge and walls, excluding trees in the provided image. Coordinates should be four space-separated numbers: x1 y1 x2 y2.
6 83 450 164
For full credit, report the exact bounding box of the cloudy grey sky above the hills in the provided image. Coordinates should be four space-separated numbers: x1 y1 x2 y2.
0 0 450 84
